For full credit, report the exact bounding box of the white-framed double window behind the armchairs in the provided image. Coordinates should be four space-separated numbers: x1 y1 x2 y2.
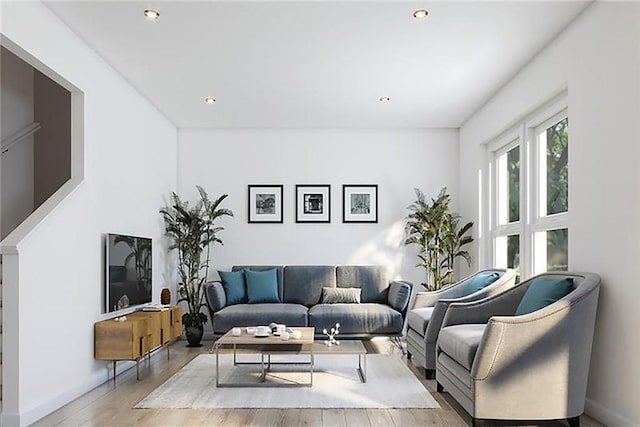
488 94 569 277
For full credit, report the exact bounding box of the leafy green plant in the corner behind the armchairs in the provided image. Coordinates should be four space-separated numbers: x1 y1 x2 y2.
405 187 473 291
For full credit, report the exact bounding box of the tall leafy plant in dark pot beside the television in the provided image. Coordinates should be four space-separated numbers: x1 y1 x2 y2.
160 186 233 347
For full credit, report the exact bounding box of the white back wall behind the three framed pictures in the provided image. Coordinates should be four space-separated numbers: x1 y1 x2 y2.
178 129 458 283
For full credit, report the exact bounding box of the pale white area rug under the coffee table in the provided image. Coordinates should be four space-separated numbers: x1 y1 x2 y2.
135 354 440 409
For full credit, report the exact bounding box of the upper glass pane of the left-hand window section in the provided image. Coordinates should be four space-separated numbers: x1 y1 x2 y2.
497 146 520 224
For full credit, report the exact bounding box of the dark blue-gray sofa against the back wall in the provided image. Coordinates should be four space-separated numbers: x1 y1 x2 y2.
205 265 412 339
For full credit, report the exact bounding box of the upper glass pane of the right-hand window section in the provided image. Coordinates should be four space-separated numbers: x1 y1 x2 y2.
538 118 569 216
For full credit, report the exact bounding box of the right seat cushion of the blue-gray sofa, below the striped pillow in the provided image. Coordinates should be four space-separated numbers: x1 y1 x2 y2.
309 303 402 334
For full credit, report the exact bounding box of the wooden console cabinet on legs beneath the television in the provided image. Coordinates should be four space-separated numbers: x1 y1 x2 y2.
94 307 182 382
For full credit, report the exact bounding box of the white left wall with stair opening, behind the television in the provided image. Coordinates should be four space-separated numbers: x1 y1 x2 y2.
1 2 177 426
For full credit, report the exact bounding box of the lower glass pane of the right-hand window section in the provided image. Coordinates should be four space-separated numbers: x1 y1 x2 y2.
534 228 569 274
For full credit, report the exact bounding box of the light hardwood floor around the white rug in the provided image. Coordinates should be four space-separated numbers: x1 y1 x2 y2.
34 340 602 427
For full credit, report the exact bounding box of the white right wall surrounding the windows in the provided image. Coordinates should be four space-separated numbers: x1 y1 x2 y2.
460 2 640 426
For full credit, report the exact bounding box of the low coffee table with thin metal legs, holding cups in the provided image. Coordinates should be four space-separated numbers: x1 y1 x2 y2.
213 327 367 387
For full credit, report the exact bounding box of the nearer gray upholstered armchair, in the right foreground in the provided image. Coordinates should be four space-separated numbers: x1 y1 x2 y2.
436 272 600 426
